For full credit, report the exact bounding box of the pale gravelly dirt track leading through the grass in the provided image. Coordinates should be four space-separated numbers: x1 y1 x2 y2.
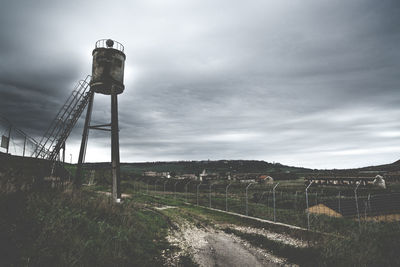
97 193 302 267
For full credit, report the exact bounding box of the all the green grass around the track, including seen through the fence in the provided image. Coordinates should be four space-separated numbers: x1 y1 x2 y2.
0 154 400 266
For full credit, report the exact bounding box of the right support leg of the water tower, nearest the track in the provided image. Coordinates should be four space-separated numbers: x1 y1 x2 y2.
111 91 121 202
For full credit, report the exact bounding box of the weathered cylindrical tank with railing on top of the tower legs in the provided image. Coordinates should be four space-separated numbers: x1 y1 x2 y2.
90 39 126 95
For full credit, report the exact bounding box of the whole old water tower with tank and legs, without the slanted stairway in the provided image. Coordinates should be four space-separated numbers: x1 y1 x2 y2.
75 39 126 202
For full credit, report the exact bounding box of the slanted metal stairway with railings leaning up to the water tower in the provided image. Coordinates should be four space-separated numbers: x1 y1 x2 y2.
32 75 91 161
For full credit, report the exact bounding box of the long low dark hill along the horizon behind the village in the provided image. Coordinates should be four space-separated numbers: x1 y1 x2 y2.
0 153 400 183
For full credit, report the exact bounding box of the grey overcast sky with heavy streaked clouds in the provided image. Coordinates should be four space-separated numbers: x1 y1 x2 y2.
0 0 400 168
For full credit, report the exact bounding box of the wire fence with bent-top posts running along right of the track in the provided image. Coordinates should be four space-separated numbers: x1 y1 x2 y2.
134 179 400 234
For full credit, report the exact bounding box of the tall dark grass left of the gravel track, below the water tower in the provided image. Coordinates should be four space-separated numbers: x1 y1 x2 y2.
0 189 169 266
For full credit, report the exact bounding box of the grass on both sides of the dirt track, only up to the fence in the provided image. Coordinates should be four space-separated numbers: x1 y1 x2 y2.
0 179 400 266
